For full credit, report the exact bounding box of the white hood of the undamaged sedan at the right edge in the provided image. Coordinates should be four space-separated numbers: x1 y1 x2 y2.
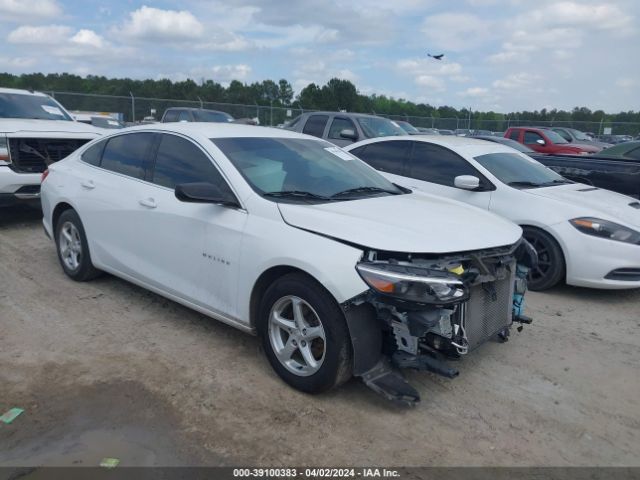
526 183 640 228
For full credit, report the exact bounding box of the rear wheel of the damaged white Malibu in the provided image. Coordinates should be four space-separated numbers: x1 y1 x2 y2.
54 209 102 282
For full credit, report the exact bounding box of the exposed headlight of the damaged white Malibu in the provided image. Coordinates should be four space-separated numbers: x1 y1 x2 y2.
356 262 469 305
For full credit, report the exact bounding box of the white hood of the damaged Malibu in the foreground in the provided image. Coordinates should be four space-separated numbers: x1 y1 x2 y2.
278 192 522 253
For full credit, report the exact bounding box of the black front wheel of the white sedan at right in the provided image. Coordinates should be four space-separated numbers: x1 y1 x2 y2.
522 227 565 291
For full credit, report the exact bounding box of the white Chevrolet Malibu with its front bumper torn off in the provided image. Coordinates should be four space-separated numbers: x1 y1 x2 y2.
42 123 536 404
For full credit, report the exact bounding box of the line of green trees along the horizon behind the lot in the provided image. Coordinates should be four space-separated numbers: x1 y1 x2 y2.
0 73 640 134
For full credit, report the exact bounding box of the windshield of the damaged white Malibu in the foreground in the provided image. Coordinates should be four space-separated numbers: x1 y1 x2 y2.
211 137 403 202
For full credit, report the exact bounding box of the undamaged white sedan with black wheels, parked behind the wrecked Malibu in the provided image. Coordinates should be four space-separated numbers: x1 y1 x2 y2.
346 136 640 290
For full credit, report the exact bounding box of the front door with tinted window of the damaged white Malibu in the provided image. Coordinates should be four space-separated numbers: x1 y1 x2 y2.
134 133 247 316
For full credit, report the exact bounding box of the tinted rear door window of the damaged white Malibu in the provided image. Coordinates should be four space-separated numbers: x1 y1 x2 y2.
100 133 154 180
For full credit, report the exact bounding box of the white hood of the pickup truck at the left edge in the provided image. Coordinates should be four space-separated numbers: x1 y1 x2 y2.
0 118 102 138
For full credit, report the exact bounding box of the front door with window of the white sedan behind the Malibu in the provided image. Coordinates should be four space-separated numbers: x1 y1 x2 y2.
405 142 495 210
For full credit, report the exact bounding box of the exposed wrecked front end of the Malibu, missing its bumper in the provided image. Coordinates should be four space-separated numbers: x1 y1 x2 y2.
342 239 537 405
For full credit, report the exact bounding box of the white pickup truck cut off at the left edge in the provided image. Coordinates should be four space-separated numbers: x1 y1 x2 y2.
0 88 102 206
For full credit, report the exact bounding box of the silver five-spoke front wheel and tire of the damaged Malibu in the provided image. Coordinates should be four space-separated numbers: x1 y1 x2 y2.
258 273 353 393
